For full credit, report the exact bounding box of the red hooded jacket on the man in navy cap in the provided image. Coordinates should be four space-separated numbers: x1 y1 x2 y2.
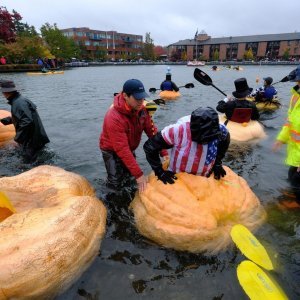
99 93 167 178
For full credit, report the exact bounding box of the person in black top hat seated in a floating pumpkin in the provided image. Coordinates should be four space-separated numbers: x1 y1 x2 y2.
216 78 259 123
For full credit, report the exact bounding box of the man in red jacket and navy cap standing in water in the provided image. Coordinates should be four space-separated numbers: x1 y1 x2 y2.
99 79 168 192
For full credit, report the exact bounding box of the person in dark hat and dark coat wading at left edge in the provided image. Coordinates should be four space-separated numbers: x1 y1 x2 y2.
0 81 50 163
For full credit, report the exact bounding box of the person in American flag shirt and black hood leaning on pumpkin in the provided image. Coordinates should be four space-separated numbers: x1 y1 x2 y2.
144 107 230 184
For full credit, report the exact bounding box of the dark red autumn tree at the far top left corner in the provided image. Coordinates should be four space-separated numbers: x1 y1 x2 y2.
0 6 22 44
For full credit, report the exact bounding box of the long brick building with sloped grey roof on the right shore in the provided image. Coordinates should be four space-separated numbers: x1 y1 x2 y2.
167 31 300 61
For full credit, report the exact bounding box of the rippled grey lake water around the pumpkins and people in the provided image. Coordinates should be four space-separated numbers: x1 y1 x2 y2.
0 66 300 300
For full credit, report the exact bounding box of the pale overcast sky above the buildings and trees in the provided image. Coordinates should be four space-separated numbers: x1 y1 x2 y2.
0 0 300 46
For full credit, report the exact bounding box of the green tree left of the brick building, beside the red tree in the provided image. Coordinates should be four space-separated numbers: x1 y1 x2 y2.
40 23 80 59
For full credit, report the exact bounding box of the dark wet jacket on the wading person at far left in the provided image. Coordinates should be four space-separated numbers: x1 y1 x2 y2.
8 93 50 150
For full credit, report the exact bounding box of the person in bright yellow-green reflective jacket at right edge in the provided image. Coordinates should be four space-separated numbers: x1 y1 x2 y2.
273 65 300 207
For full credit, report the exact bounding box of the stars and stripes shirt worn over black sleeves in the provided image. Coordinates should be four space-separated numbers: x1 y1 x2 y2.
161 116 228 176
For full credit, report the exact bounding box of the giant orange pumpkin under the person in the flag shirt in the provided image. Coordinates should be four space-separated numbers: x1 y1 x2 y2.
131 167 265 253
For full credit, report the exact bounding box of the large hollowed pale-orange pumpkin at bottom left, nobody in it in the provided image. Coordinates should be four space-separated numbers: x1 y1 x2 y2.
0 166 106 300
